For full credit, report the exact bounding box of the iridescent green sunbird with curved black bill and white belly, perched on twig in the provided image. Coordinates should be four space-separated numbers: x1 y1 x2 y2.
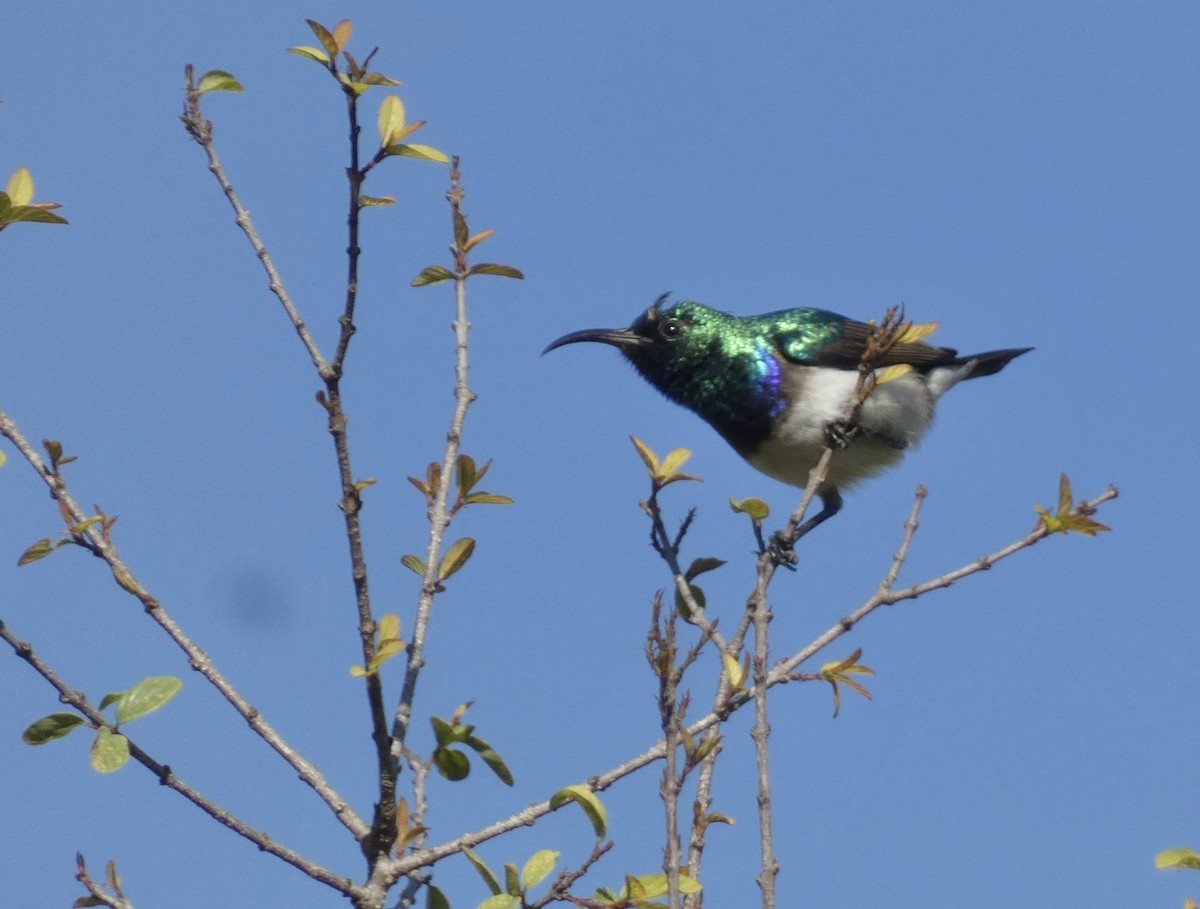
542 295 1032 530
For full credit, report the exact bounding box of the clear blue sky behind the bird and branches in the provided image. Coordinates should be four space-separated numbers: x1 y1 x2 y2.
0 0 1200 909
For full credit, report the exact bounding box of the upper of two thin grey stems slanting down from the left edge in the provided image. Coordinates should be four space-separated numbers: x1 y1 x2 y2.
0 411 367 839
